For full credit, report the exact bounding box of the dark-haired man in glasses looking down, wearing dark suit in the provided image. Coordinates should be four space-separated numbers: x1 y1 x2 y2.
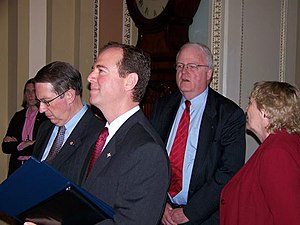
33 61 105 184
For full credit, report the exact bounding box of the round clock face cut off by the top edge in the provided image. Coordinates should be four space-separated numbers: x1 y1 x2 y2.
136 0 168 19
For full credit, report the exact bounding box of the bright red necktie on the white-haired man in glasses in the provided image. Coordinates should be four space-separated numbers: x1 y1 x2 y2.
169 100 191 198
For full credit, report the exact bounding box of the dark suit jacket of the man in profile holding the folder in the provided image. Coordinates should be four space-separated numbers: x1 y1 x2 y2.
83 110 169 225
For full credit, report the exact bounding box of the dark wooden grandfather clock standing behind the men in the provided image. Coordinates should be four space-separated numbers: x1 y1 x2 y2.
126 0 200 116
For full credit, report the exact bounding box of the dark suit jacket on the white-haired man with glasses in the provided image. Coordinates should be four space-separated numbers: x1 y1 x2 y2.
151 88 245 225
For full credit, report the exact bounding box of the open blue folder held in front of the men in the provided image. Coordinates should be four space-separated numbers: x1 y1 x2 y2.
0 158 114 225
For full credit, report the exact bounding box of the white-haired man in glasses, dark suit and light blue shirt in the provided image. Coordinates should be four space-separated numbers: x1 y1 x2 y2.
151 43 245 225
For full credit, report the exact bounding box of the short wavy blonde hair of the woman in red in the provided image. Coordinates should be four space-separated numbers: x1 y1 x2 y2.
250 81 300 135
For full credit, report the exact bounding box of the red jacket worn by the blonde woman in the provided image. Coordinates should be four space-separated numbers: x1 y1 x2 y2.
220 131 300 225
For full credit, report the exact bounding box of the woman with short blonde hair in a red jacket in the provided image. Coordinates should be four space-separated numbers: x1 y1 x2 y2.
220 81 300 225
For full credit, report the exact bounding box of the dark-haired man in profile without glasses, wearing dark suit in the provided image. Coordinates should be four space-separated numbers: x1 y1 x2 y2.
83 43 169 225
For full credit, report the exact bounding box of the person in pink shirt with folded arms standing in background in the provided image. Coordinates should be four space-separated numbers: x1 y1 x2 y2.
2 79 47 176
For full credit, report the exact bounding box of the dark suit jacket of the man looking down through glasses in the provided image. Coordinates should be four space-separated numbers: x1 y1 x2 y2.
33 109 105 184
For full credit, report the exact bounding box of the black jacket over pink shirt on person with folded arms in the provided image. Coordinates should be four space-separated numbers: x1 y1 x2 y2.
2 108 47 175
